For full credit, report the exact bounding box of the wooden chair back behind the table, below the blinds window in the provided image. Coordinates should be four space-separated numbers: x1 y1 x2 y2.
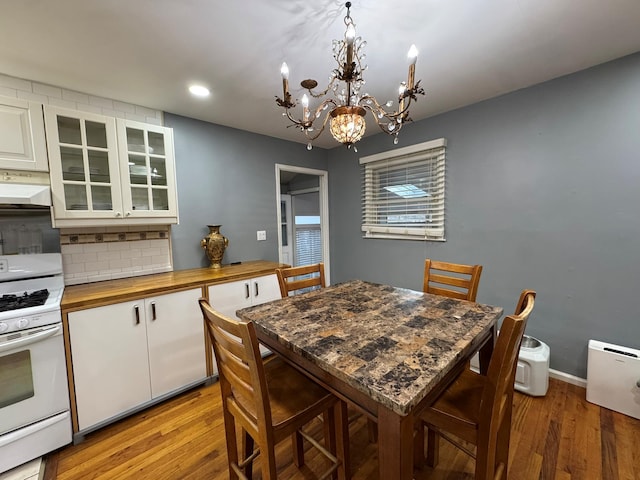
422 258 482 302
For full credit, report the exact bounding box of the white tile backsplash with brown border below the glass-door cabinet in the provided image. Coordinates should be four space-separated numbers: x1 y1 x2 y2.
60 225 173 285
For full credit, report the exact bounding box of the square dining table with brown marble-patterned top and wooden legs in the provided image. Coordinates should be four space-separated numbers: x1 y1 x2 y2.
236 280 503 480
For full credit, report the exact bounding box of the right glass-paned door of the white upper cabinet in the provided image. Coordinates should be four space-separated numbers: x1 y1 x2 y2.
117 119 177 218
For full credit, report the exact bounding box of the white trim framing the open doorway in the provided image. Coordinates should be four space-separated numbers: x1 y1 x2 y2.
276 163 331 285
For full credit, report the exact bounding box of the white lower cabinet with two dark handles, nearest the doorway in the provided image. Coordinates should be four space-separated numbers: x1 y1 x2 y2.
208 274 281 356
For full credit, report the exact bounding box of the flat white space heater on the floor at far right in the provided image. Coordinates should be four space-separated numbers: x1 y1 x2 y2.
587 340 640 419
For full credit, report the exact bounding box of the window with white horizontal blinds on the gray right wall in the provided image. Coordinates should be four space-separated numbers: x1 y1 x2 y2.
360 138 447 241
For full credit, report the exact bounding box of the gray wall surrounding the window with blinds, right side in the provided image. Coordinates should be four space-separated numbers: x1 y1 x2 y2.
329 50 640 378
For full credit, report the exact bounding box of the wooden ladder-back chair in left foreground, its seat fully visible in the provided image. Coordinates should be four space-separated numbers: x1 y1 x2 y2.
199 298 350 480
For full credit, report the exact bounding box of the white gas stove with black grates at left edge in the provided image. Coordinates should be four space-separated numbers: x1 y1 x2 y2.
0 253 71 473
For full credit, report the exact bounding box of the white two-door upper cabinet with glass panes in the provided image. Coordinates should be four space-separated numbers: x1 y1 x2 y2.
45 105 178 228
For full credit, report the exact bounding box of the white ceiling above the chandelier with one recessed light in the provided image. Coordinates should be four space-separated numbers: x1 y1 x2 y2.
0 0 640 148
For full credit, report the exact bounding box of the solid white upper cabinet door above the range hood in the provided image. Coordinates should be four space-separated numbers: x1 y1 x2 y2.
0 97 49 172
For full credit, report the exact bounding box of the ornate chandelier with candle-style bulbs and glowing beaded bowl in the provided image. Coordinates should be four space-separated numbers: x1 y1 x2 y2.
276 2 424 151
